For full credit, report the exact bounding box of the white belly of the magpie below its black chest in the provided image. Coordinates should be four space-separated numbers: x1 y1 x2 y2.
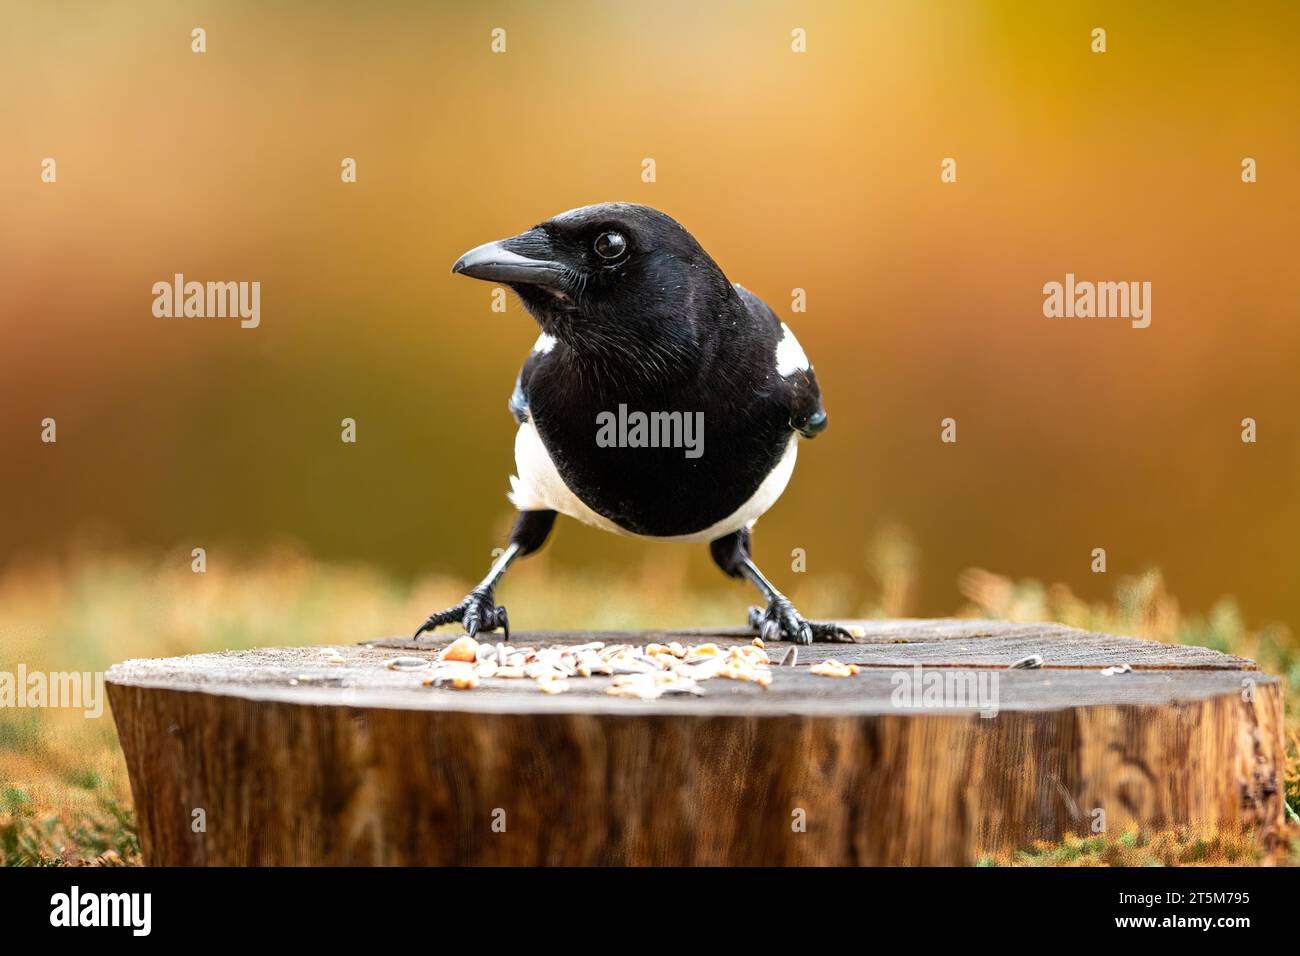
508 421 798 542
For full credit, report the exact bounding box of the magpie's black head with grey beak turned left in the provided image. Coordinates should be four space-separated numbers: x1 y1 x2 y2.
451 203 735 349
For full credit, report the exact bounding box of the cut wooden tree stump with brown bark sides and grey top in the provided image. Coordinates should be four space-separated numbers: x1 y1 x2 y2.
108 620 1284 866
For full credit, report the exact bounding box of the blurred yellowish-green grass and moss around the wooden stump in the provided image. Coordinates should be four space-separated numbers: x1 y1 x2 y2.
0 531 1300 866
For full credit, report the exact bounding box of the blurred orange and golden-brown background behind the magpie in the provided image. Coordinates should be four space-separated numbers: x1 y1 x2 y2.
0 0 1300 856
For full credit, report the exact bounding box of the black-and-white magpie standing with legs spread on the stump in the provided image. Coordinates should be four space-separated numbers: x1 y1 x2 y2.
415 203 853 644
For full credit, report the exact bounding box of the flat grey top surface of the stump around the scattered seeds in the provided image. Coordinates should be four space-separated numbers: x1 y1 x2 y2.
108 619 1277 715
